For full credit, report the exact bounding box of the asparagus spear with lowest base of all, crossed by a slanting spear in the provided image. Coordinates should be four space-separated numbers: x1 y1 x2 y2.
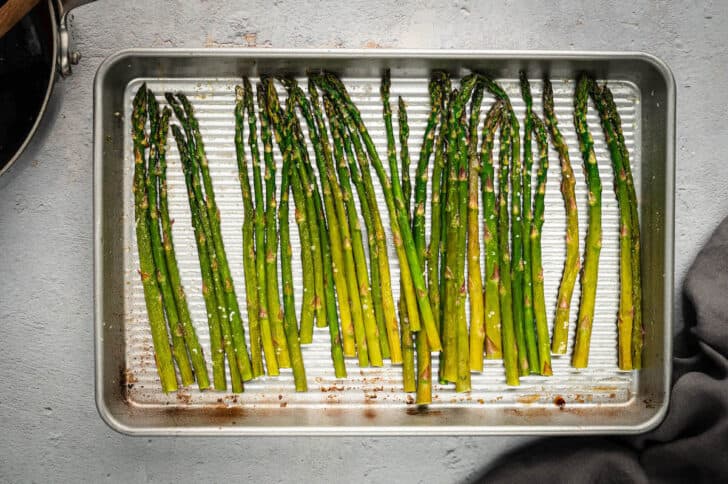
412 72 444 405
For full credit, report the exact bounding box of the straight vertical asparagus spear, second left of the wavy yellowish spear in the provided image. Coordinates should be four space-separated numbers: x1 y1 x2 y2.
520 71 541 374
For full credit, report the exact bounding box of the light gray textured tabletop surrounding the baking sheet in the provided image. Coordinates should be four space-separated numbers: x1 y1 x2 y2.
0 0 728 482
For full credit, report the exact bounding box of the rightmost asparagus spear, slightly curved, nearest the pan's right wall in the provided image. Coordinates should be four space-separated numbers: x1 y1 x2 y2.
602 86 644 370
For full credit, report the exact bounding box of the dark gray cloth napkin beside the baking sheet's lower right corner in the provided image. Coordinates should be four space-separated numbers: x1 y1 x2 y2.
481 219 728 484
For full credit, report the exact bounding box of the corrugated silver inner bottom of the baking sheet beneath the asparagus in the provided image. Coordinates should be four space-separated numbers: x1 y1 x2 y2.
123 74 641 407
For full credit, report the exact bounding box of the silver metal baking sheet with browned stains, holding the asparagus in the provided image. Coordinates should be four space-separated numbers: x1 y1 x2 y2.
95 50 674 434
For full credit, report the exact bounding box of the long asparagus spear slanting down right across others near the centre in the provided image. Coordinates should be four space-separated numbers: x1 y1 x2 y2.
317 70 441 351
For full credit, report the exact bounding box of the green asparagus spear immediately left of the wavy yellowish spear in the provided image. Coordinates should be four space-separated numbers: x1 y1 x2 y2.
530 113 553 376
